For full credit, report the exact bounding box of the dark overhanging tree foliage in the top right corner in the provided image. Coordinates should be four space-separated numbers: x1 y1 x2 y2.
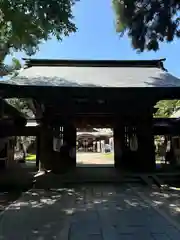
112 0 180 52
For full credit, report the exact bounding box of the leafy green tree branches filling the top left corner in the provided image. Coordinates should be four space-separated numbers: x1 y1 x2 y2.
0 0 77 62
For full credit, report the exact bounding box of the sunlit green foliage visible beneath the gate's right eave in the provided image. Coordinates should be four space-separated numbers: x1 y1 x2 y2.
154 100 180 117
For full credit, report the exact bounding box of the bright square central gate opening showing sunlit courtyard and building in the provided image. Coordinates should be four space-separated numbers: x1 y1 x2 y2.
76 128 114 167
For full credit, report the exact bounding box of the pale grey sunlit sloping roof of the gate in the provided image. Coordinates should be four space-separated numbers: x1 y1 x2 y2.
2 58 180 88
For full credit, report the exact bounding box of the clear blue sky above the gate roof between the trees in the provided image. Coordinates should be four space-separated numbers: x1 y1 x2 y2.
6 0 180 77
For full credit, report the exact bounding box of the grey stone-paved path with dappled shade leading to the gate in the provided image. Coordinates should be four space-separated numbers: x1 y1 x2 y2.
0 184 180 240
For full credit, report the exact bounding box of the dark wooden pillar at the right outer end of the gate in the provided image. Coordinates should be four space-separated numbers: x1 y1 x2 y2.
136 116 156 172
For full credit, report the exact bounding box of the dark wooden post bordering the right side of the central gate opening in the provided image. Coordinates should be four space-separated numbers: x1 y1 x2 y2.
114 123 124 168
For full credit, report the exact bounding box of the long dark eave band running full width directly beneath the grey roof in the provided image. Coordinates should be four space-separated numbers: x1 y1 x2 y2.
0 84 172 102
